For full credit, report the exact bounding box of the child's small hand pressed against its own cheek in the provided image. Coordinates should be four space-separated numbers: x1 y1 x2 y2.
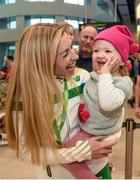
100 57 120 74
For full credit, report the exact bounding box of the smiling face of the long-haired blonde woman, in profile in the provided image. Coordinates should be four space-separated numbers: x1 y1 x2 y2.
55 33 78 77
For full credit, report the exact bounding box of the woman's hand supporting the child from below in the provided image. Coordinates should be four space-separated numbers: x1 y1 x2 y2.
88 136 117 159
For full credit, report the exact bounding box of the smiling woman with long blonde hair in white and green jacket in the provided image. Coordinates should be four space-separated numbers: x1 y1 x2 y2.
6 24 116 178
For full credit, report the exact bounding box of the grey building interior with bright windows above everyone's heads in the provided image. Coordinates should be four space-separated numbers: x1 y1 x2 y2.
0 0 140 64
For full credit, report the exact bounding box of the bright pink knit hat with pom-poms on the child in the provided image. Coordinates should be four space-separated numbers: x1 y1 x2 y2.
93 25 139 70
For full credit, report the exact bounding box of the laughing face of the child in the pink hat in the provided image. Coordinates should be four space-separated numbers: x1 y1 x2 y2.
92 40 124 71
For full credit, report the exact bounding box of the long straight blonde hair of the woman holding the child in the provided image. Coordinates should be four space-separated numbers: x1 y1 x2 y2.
6 23 63 165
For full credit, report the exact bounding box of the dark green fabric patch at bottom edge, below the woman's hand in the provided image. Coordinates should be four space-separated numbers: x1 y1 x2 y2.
96 164 112 179
